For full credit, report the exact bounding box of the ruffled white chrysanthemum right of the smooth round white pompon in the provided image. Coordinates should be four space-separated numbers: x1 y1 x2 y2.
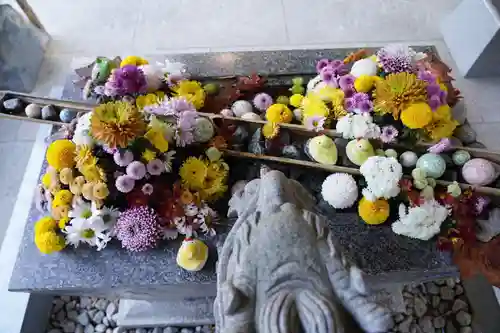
359 156 403 201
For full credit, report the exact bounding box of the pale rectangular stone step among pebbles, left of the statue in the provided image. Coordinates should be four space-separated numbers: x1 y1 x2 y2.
118 297 215 328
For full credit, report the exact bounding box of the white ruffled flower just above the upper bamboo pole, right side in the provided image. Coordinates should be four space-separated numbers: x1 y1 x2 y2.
336 113 380 139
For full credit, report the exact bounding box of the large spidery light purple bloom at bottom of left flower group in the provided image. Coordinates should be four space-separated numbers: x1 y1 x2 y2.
115 206 162 252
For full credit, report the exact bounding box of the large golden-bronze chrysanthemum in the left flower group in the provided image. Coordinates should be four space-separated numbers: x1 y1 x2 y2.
91 102 146 148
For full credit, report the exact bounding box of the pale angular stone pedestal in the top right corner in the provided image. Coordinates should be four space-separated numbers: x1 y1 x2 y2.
441 0 500 77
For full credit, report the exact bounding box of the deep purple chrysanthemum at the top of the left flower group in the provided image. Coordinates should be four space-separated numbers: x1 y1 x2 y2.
104 65 147 96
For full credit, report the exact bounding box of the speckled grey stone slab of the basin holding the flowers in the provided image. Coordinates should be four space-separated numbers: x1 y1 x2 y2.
9 47 458 300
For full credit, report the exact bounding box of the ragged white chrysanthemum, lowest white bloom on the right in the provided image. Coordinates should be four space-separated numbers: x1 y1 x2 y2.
392 199 449 240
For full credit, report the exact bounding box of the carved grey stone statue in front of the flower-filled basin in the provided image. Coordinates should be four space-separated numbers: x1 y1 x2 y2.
214 170 393 333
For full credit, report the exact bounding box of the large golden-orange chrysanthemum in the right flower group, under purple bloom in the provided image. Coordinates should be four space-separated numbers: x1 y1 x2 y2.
373 72 427 120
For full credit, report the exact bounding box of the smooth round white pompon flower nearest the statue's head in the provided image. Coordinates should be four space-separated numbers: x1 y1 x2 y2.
321 173 358 209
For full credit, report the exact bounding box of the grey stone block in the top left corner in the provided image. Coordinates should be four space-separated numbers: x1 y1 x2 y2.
0 5 49 92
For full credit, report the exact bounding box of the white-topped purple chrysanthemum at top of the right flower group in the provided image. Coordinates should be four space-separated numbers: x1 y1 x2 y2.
377 44 416 73
